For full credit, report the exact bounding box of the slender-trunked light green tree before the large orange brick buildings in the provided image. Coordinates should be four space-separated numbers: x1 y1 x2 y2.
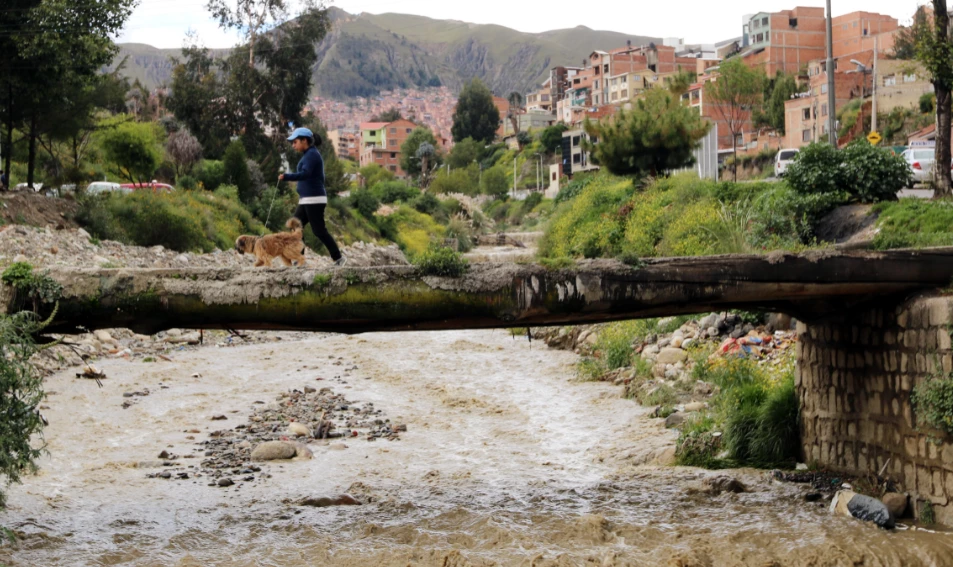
704 57 765 181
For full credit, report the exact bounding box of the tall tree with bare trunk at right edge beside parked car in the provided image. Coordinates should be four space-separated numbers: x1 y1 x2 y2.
915 0 953 198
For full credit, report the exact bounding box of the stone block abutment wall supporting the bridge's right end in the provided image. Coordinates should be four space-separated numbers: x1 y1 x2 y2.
796 297 953 525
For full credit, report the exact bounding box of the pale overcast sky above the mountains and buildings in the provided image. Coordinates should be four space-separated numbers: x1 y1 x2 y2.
118 0 925 48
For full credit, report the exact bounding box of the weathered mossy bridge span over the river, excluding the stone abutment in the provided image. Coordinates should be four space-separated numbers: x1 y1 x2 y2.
0 248 953 333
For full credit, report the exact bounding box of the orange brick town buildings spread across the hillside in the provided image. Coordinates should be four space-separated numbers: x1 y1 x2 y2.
326 6 935 178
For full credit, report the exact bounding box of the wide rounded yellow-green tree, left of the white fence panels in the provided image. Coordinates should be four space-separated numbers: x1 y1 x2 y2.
584 89 710 175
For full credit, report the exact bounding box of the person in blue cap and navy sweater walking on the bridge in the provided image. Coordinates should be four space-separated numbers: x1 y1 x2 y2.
278 128 347 266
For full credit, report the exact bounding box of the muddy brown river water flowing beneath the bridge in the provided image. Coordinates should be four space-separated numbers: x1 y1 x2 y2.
0 331 953 567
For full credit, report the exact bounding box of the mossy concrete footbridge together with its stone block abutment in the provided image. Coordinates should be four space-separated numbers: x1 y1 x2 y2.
0 248 953 525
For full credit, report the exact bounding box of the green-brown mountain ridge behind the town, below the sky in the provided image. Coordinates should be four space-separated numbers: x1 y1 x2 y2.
117 8 660 99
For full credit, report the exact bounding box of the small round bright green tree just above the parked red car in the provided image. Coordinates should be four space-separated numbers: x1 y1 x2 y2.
100 121 162 183
